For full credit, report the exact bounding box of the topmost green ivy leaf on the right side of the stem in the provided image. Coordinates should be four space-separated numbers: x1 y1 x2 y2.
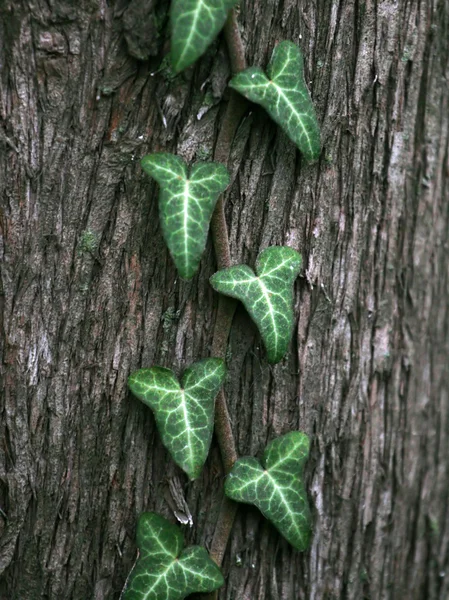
229 41 320 160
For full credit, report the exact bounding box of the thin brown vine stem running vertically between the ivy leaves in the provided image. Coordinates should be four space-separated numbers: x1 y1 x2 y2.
207 9 247 584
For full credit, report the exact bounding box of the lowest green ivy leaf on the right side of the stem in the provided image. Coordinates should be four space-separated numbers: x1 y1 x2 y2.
225 431 311 550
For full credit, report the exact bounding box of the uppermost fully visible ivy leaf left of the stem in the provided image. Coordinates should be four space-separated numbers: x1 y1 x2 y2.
141 152 229 279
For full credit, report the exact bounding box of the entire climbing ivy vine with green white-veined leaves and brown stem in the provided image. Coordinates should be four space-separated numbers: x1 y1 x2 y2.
122 0 320 600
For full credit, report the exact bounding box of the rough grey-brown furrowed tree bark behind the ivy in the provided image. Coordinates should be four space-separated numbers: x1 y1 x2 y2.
0 0 449 600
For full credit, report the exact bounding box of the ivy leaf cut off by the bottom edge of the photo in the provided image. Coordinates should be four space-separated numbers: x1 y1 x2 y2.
122 513 224 600
